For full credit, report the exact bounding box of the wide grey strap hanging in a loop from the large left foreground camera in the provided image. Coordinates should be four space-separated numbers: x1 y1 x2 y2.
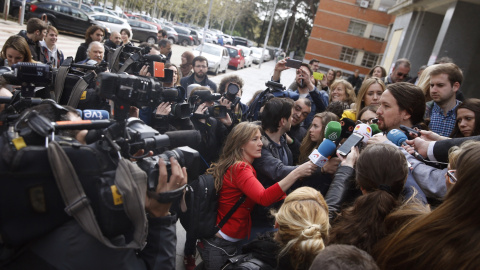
48 141 148 249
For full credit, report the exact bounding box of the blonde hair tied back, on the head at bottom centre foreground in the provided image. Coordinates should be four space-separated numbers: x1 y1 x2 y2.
272 187 330 269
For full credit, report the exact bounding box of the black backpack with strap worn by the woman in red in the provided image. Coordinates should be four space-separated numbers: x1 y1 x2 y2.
186 174 246 239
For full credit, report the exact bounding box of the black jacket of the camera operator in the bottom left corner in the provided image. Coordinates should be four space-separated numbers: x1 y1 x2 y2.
2 215 177 270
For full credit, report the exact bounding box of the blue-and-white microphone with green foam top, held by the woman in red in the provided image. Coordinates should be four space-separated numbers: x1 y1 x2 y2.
308 121 342 167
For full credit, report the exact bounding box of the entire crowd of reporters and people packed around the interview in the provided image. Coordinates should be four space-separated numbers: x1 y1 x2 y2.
0 19 480 270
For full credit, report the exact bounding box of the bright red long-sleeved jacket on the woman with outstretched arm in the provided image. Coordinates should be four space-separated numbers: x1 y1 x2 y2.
217 162 286 239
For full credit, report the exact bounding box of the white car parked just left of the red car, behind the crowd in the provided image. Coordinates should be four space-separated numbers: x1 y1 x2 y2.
193 43 230 75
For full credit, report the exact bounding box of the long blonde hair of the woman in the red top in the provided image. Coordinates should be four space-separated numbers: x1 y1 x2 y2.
207 122 260 192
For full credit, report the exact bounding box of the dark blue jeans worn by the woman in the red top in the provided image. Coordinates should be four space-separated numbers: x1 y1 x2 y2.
197 236 241 270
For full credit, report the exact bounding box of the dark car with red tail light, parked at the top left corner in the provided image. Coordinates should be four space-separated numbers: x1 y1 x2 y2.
25 1 99 35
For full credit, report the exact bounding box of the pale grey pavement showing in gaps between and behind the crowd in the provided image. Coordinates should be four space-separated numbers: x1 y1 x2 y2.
0 19 295 270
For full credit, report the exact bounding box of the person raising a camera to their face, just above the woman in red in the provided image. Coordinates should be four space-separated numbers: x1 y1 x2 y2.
218 75 248 125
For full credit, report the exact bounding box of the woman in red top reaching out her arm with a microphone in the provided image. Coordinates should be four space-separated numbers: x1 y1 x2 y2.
197 122 316 270
